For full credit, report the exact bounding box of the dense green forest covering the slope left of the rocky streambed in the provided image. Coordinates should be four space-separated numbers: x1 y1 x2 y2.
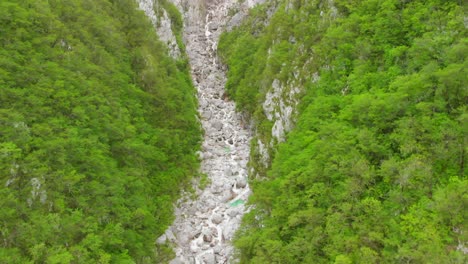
0 0 201 264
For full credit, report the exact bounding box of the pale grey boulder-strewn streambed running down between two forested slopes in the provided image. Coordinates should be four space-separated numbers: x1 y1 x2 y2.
139 1 260 264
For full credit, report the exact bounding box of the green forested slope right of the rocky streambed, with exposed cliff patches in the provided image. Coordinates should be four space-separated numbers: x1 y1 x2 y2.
219 0 468 264
